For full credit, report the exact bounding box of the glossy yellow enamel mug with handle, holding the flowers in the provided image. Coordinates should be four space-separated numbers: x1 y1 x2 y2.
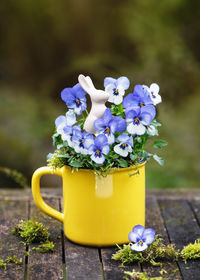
32 163 145 246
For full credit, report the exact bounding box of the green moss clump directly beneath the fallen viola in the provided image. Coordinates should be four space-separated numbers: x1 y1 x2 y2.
112 235 179 266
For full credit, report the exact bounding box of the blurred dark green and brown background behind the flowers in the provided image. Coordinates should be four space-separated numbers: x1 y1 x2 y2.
0 0 200 188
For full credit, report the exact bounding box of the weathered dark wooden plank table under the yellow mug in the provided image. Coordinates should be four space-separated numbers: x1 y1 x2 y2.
0 189 200 280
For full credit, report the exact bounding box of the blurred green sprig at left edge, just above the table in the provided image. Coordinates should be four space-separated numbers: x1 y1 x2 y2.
0 166 30 189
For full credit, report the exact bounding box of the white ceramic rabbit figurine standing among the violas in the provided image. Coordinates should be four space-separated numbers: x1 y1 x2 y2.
78 74 109 134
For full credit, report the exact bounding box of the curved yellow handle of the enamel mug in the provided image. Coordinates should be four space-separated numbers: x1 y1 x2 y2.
32 166 64 223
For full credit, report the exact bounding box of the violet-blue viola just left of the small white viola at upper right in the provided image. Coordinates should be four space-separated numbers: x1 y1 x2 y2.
122 85 153 110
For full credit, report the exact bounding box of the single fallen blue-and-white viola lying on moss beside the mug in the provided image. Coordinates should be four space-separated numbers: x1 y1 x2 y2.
128 225 156 252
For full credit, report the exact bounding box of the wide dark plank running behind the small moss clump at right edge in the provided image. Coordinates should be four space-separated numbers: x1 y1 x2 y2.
159 200 200 280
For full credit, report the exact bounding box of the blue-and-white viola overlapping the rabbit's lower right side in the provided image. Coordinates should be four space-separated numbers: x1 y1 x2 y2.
94 108 126 144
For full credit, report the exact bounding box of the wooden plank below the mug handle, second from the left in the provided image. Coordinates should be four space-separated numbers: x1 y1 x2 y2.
28 198 63 280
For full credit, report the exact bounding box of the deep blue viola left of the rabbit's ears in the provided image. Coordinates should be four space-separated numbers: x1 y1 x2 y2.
61 83 87 115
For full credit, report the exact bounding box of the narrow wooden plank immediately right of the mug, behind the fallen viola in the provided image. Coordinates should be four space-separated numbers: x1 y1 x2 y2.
142 196 182 280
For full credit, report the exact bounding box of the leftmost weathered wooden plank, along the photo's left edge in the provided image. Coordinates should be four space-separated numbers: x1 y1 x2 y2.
0 200 28 280
